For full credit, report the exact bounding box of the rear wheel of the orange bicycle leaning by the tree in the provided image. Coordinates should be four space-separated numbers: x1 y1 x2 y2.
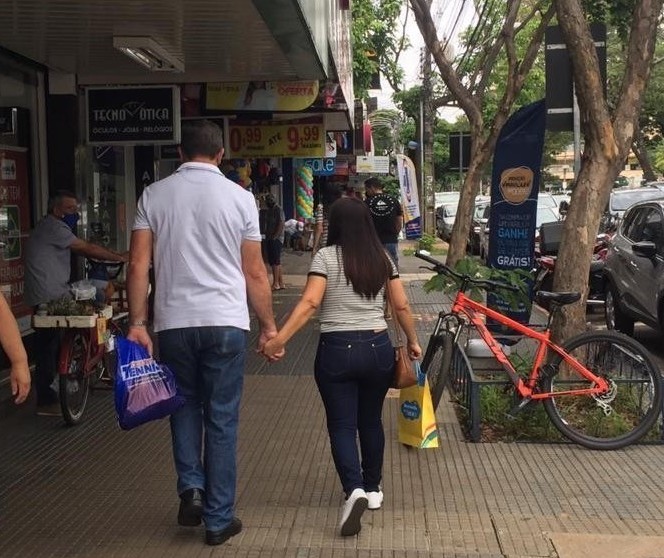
542 331 662 450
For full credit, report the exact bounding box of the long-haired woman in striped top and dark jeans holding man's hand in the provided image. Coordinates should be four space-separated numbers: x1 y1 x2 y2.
263 198 422 536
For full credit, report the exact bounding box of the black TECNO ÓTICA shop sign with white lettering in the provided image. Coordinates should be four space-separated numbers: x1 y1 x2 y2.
86 86 180 145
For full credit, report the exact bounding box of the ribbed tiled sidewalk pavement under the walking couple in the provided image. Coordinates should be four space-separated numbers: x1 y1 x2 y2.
0 247 664 558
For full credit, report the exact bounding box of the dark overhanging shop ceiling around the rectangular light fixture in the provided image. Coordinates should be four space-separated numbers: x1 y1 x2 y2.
0 0 326 85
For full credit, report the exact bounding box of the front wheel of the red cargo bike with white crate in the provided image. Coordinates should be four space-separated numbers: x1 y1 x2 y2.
60 332 90 426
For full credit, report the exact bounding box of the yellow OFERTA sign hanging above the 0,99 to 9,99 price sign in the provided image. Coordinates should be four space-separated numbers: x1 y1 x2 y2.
205 81 318 112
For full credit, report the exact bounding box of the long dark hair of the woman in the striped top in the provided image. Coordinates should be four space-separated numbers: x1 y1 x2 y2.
327 198 392 298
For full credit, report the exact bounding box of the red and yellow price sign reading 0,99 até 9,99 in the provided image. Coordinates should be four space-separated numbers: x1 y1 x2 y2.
228 119 326 159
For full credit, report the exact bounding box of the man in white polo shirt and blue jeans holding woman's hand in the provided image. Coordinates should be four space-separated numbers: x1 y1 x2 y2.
127 120 277 545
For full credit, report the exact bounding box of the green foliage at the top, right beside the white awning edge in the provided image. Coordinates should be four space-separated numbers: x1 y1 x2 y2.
351 0 408 98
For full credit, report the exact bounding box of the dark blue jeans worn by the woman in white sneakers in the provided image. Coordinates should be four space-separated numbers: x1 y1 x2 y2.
314 331 394 494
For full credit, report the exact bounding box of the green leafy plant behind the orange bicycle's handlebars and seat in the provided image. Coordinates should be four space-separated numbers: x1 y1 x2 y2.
424 257 532 309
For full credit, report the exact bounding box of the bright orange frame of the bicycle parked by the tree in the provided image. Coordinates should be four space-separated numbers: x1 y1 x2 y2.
451 290 609 401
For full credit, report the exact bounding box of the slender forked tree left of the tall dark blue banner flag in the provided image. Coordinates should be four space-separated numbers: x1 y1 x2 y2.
410 0 555 265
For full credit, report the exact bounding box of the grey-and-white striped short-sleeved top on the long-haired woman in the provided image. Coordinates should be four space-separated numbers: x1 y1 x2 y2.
309 245 399 333
